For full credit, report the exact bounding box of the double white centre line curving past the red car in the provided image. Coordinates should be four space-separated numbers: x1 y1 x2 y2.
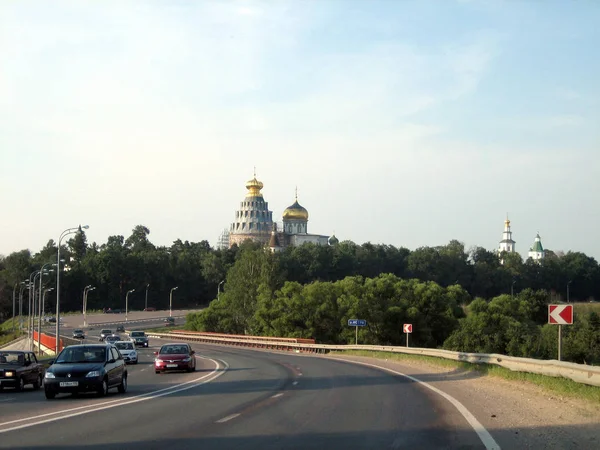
0 356 229 434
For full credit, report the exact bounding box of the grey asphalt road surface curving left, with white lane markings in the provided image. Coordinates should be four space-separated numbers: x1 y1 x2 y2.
0 342 492 450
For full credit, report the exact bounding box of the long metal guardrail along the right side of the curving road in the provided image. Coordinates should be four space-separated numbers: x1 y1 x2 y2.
148 332 600 387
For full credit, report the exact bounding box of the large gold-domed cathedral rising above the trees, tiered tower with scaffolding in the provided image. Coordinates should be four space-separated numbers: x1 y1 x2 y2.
227 174 332 252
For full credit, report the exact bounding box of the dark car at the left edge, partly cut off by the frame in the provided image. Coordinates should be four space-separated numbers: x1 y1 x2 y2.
0 350 44 391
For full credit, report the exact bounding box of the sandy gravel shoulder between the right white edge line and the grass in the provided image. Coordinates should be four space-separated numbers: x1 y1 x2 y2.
326 354 600 449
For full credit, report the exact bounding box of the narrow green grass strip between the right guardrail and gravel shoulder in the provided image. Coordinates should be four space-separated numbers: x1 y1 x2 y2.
331 350 600 404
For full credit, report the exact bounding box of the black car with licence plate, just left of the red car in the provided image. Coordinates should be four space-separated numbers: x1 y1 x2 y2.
44 344 127 399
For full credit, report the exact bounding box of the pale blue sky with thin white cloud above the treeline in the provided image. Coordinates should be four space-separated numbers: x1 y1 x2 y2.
0 0 600 259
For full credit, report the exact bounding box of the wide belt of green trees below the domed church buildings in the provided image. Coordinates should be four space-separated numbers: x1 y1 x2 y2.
0 225 600 363
